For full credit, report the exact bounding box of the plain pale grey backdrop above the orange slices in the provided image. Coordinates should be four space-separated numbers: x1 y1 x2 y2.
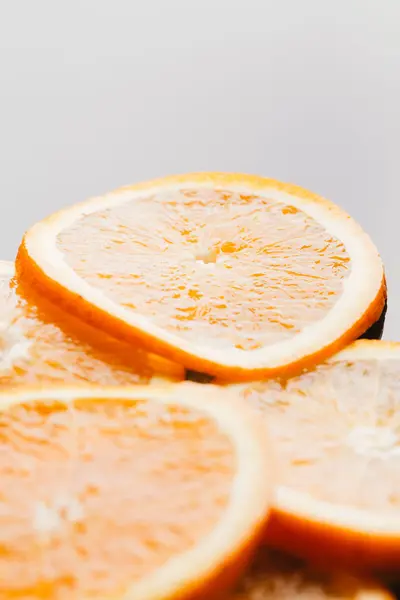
0 0 400 339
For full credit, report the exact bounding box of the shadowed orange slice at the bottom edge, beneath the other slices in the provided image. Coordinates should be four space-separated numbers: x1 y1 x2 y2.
231 548 395 600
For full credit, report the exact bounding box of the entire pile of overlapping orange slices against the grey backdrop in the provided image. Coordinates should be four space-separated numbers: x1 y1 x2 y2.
0 173 400 600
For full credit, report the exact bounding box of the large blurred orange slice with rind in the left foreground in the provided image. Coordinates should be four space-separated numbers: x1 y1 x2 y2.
0 384 271 600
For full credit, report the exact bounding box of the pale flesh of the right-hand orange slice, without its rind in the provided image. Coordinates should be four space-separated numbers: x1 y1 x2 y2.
238 359 400 515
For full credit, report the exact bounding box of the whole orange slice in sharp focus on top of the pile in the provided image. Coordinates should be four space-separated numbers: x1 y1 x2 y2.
17 173 386 380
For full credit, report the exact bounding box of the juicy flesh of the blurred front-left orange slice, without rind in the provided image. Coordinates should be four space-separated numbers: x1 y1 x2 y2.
0 400 235 599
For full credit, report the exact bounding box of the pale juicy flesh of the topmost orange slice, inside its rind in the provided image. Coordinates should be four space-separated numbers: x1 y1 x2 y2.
57 187 351 350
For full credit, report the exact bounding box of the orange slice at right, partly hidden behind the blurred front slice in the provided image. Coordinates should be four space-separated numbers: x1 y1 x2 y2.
232 340 400 572
